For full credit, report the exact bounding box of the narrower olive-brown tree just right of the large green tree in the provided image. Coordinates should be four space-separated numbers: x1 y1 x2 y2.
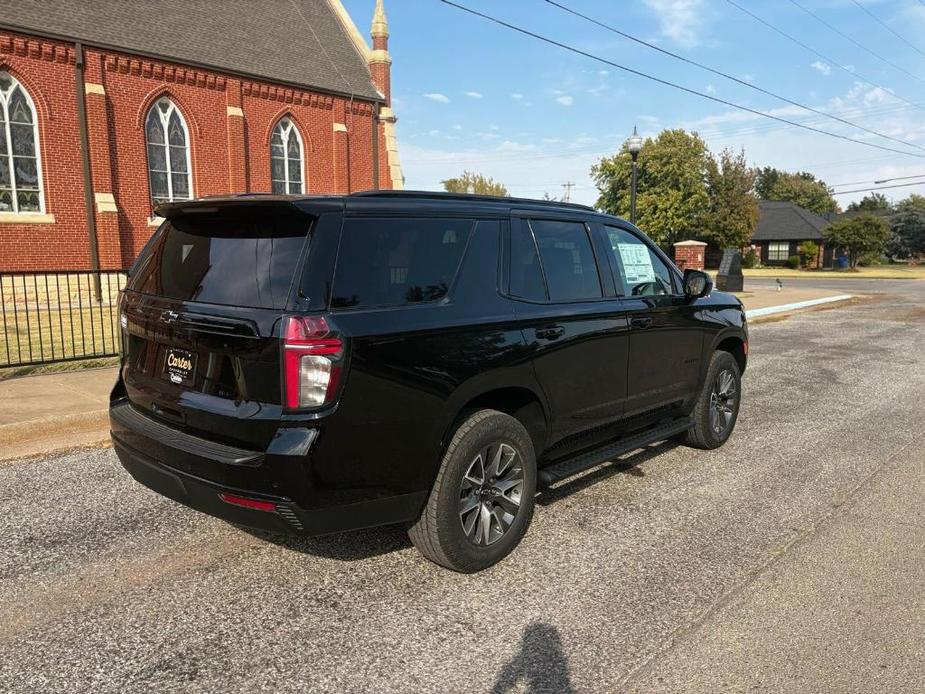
701 149 759 248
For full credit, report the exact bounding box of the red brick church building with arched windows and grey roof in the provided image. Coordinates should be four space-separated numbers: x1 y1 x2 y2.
0 0 403 271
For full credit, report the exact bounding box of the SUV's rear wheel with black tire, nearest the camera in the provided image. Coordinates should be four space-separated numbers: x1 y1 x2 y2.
408 410 536 573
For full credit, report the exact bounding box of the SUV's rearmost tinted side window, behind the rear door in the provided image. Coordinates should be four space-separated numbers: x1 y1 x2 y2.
331 218 472 308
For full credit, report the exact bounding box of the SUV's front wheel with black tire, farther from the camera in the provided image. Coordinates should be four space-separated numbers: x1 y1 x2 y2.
680 351 742 450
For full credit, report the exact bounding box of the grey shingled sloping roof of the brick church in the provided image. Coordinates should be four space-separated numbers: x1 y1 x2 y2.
0 0 381 100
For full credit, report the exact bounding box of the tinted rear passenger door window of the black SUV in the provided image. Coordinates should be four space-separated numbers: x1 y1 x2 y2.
530 219 602 301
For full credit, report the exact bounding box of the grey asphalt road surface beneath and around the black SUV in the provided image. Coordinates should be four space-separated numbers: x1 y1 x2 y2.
0 280 925 692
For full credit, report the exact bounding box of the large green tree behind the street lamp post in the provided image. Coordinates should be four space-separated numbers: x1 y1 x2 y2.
591 130 710 248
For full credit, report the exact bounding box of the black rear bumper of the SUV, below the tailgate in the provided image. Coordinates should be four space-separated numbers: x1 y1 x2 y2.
110 403 426 535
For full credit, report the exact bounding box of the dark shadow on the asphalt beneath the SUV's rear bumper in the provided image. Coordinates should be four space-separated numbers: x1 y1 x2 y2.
235 525 411 561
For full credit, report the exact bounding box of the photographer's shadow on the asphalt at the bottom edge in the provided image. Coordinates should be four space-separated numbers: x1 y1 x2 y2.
491 622 575 694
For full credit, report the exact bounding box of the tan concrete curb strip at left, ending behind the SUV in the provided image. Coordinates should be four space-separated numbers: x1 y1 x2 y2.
0 409 109 462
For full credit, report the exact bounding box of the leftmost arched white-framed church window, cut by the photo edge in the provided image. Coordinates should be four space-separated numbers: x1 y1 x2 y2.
0 72 45 214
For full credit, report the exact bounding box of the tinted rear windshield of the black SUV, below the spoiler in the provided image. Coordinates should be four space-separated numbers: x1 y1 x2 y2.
129 213 309 309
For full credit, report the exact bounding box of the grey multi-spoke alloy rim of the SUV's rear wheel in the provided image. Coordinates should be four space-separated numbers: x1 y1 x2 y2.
459 443 524 547
